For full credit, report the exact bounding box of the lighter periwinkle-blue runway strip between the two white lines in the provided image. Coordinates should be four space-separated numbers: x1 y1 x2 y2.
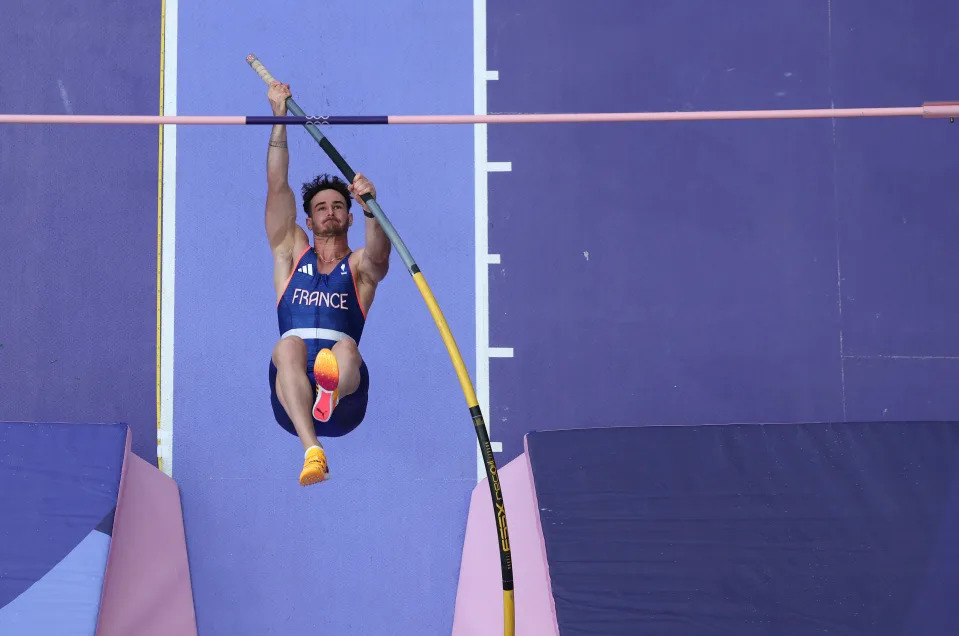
173 0 476 636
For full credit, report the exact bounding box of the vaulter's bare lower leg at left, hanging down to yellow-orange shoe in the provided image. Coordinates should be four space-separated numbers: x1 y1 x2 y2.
273 336 320 450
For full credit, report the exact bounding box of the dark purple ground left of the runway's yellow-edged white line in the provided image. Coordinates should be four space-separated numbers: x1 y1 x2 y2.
0 0 160 465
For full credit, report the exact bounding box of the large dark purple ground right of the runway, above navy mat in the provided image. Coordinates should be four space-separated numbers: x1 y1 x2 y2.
488 0 959 462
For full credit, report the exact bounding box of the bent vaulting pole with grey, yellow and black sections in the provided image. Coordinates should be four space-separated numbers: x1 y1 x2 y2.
246 54 516 636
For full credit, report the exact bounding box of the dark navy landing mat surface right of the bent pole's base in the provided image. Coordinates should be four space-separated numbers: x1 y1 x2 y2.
526 422 959 636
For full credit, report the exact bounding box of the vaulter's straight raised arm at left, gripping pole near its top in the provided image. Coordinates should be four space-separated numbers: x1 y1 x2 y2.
266 82 297 255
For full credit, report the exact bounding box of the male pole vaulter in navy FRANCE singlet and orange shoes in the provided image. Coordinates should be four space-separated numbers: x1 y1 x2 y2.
266 82 390 486
